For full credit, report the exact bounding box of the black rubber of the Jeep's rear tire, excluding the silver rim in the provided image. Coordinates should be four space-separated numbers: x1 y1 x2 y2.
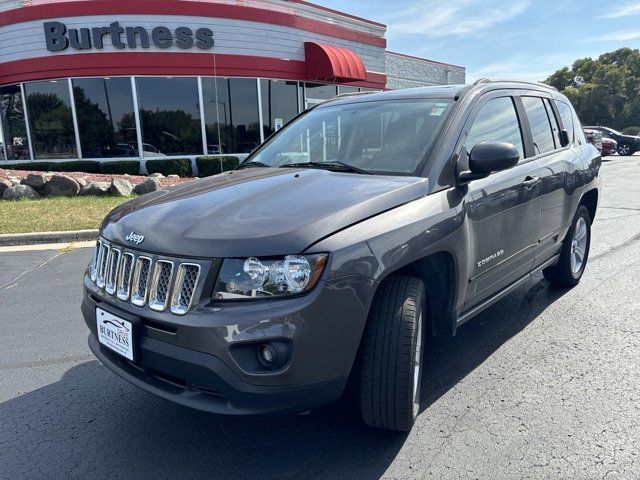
542 205 591 287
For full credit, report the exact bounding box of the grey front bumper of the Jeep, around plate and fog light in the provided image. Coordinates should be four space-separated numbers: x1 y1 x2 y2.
82 277 372 415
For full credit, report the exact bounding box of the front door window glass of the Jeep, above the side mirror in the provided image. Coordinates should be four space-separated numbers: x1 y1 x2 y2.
464 97 524 159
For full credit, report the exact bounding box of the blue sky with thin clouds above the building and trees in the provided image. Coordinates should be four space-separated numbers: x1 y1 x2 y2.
314 0 640 82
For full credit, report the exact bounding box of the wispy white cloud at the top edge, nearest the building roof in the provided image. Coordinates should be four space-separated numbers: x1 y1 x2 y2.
387 0 531 37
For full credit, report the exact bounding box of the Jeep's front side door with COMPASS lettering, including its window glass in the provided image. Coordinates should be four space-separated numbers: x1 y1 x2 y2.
460 92 541 309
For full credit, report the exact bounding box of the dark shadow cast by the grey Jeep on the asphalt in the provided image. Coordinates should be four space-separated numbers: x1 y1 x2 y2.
0 280 562 479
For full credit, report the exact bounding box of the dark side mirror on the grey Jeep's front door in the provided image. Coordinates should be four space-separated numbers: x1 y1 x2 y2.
458 142 520 183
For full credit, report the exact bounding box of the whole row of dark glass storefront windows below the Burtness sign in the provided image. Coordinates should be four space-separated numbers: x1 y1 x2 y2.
0 77 362 160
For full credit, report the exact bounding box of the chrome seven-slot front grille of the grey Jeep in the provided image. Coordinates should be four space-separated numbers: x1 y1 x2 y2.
90 239 202 315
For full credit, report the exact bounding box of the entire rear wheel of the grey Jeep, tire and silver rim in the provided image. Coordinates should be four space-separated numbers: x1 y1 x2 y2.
542 205 591 287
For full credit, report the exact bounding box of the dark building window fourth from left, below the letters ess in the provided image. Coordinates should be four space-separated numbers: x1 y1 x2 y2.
136 77 202 157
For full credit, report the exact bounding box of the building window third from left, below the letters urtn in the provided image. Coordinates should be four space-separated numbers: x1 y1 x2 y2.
73 77 138 158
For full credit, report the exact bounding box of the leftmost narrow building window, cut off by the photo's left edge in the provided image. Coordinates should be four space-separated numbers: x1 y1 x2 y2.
0 85 30 160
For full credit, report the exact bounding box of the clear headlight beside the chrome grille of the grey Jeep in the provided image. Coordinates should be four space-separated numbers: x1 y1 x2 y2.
213 254 327 300
